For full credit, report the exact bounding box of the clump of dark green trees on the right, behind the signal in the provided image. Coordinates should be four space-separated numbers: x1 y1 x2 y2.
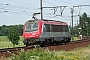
74 13 90 36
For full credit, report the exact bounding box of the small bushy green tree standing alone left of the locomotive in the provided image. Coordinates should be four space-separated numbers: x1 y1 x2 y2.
7 28 20 47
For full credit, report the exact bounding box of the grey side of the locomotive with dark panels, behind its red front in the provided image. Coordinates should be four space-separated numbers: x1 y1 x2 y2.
40 24 71 41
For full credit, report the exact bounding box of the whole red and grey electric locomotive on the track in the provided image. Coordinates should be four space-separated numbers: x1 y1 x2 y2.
23 20 71 46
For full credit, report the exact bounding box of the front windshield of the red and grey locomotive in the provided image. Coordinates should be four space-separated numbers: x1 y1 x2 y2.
25 22 38 32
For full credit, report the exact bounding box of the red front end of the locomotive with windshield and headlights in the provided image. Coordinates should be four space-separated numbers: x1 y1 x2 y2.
23 20 40 46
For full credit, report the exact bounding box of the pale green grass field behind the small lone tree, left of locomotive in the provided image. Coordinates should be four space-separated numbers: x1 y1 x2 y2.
0 36 24 49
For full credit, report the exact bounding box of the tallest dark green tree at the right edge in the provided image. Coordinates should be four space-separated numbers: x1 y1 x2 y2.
80 13 90 36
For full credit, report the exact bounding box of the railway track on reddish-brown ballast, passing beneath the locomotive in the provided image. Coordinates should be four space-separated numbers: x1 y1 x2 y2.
0 38 90 57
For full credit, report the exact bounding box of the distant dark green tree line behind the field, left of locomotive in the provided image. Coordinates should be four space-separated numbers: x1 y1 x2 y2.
0 24 23 36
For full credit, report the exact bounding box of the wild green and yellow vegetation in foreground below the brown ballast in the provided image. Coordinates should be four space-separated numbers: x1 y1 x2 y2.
8 47 90 60
